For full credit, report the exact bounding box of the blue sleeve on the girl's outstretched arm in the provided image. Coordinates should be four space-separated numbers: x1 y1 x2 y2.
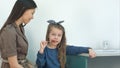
66 46 89 55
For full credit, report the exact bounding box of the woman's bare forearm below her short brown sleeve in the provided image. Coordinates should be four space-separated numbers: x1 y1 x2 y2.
8 56 23 68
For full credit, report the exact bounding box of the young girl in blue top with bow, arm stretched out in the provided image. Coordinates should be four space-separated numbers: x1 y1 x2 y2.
36 20 95 68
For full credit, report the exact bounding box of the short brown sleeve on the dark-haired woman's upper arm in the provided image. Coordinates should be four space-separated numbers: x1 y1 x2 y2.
1 29 17 58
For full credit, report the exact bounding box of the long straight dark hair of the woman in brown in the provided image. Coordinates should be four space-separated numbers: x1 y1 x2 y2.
0 0 37 34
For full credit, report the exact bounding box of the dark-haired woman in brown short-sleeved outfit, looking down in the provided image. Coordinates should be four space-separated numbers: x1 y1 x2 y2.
0 0 37 68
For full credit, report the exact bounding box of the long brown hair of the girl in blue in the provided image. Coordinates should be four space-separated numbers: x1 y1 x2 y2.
46 20 66 68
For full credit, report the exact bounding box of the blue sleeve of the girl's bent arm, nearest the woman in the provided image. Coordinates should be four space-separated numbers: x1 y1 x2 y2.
36 52 45 68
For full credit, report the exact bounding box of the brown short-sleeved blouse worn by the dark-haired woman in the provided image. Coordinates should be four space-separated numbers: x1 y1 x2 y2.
0 23 28 60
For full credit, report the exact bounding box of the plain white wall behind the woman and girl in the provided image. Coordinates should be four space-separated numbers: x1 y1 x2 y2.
0 0 120 62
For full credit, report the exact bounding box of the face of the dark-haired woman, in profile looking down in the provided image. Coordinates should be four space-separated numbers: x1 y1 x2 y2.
22 9 35 24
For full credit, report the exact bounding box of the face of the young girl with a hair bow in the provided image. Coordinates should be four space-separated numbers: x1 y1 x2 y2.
49 27 63 46
